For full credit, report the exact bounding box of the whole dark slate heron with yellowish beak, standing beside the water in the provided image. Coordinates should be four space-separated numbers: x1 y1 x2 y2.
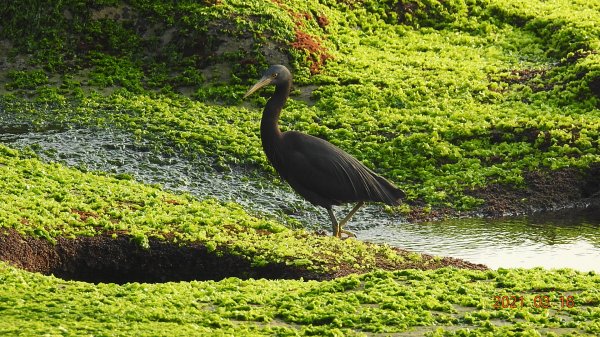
244 65 405 237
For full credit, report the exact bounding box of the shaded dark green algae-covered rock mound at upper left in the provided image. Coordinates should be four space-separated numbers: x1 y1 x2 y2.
0 0 318 81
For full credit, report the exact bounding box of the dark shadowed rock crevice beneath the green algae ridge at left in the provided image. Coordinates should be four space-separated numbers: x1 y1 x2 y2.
0 229 324 284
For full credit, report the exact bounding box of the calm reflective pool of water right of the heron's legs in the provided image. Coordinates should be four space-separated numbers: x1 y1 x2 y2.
359 214 600 272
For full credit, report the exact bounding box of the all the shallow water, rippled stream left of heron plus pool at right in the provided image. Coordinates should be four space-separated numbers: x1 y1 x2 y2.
0 125 600 272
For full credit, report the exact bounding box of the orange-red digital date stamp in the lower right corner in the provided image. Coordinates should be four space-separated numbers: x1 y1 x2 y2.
493 294 575 309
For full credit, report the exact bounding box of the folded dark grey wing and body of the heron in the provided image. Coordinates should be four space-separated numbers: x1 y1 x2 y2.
280 132 404 205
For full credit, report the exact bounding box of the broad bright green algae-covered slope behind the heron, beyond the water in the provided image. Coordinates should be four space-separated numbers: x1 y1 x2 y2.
2 0 600 210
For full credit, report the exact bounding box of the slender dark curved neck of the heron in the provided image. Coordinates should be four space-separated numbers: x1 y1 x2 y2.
260 82 291 150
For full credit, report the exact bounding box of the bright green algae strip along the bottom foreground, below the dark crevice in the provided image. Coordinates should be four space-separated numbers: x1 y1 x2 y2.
0 263 600 336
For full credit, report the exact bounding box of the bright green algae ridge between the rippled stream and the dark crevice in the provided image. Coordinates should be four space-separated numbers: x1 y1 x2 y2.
0 146 402 272
